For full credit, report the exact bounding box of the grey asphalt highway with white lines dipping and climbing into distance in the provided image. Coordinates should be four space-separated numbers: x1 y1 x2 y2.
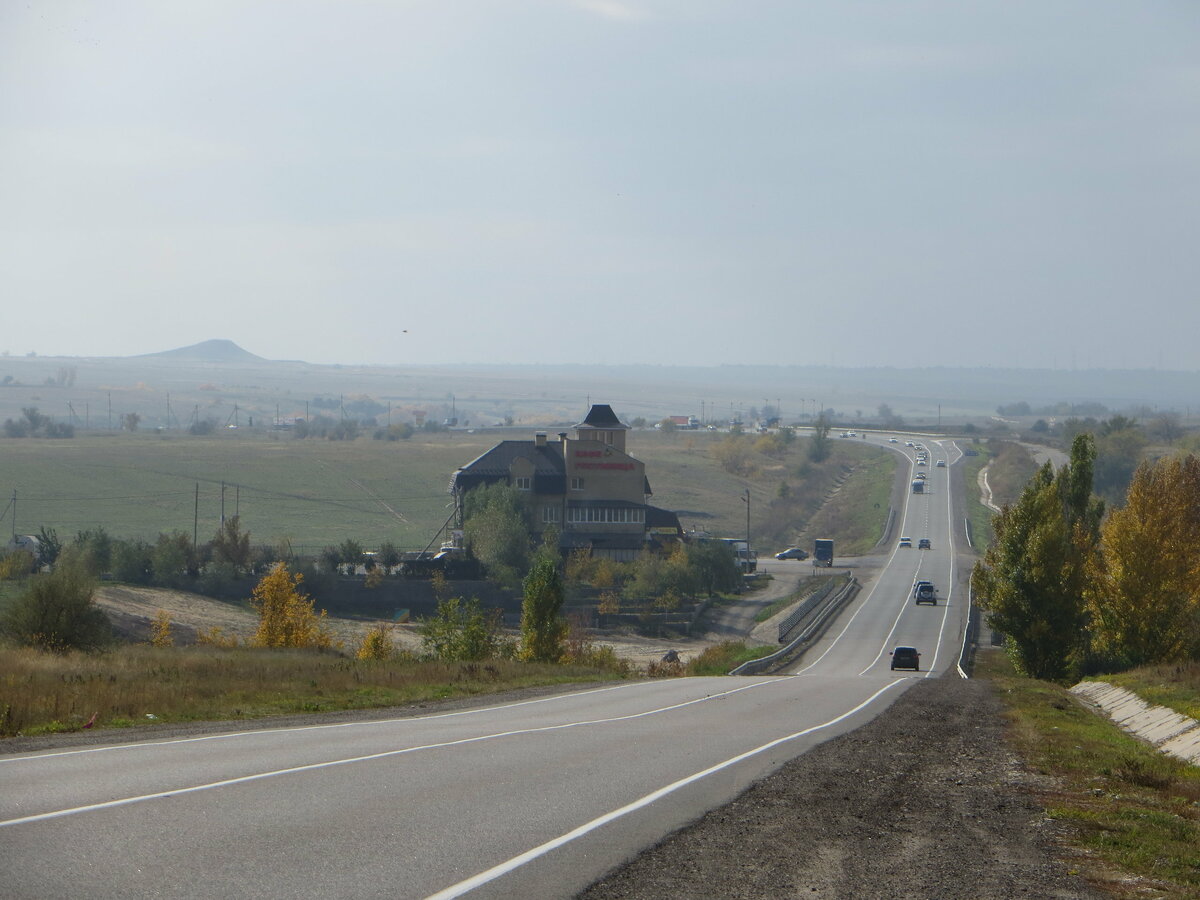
0 436 966 898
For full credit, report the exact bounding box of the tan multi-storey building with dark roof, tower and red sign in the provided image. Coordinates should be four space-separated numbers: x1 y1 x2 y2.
450 403 683 562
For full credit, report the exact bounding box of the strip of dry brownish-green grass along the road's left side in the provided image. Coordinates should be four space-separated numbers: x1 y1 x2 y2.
0 644 617 737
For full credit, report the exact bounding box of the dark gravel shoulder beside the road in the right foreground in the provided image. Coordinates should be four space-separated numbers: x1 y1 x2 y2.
580 676 1104 900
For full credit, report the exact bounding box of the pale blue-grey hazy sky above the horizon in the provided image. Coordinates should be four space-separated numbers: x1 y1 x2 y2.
0 0 1200 370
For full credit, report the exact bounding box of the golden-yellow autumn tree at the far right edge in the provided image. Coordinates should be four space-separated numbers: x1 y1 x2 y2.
1088 455 1200 666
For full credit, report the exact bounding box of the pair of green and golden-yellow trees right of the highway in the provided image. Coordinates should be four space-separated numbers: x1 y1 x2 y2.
972 433 1200 680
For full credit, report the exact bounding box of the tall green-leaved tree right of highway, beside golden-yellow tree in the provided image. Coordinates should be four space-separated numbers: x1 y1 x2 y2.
971 434 1104 680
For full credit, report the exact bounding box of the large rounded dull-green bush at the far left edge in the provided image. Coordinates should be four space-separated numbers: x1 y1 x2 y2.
0 559 113 653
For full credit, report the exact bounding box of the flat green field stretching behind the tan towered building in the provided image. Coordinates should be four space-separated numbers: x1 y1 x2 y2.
0 428 887 553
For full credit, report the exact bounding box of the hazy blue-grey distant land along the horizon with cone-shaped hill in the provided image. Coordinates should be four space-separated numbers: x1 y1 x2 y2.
0 340 1200 430
